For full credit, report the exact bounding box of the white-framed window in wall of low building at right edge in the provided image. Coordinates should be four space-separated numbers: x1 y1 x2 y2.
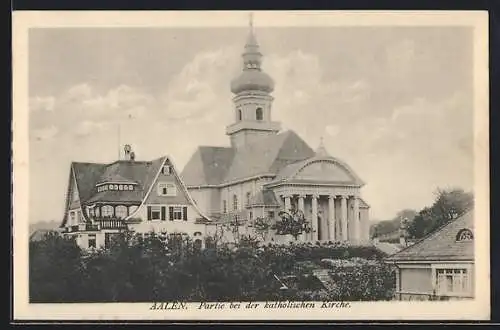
435 268 472 296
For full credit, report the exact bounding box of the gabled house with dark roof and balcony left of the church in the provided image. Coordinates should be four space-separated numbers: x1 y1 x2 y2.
60 145 209 248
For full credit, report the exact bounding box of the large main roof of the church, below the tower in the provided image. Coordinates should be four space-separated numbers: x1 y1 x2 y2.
182 131 314 186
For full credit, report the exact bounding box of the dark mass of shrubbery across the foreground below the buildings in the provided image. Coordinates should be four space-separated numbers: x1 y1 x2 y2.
30 235 392 302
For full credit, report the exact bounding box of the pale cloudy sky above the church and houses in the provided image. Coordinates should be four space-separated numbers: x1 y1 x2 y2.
28 26 473 222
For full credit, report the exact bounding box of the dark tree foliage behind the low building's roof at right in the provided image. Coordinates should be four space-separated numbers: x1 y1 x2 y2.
408 189 474 238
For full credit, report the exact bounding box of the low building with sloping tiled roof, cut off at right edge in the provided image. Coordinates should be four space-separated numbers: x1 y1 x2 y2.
386 211 474 300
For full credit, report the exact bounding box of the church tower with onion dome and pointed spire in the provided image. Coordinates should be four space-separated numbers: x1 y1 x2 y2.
226 16 280 148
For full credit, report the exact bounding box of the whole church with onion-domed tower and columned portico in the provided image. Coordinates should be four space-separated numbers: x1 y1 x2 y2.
180 18 369 244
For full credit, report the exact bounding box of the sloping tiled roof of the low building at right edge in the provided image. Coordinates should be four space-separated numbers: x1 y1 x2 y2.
386 211 474 262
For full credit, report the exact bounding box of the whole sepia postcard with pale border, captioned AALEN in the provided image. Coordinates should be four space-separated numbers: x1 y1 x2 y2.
13 11 489 320
